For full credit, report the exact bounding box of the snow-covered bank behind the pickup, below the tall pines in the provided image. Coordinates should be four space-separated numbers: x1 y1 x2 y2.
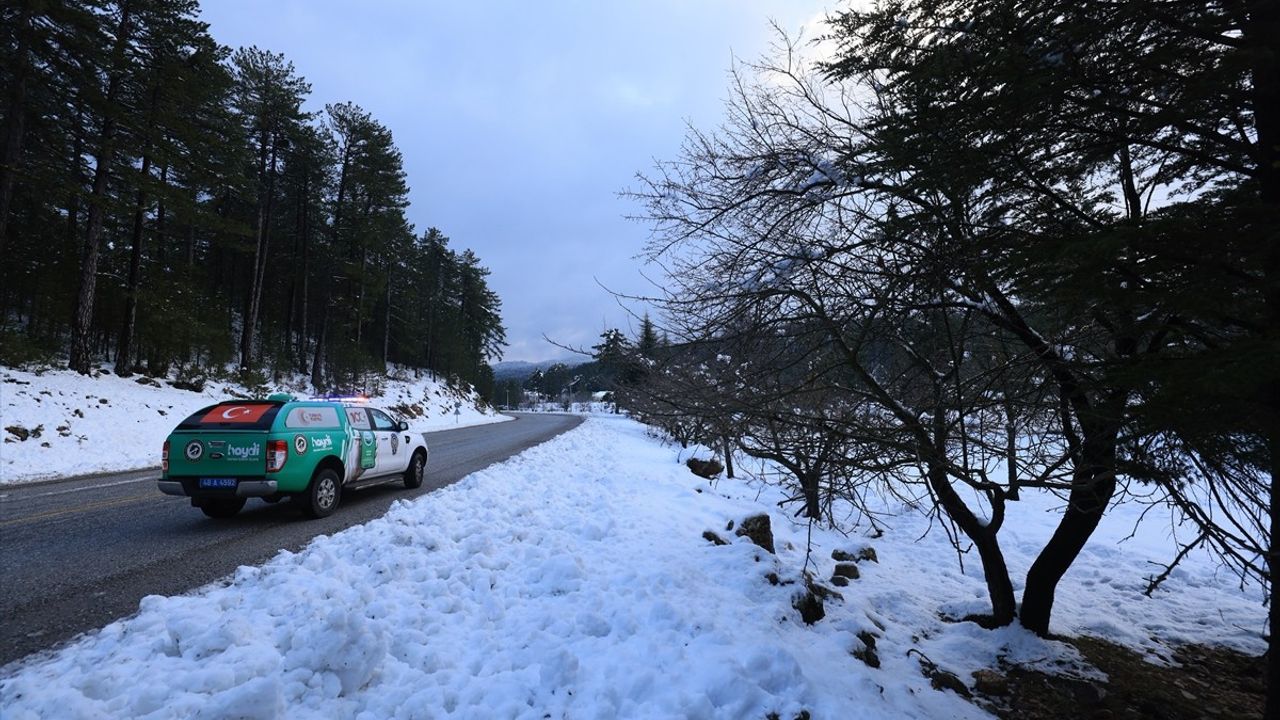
0 368 509 484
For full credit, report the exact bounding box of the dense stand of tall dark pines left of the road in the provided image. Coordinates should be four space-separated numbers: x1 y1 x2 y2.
0 0 504 392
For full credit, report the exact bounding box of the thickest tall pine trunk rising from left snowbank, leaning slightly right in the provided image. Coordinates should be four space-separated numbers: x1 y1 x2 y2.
68 1 131 374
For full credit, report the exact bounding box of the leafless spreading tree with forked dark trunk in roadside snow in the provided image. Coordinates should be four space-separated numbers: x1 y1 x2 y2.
635 26 1259 633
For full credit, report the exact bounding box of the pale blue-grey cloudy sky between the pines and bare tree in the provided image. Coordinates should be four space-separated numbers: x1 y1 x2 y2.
194 0 832 361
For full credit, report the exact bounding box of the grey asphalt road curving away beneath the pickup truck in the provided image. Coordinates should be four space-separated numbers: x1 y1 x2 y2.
0 415 581 666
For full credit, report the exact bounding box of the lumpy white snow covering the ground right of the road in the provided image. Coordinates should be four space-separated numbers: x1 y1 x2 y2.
0 416 1265 720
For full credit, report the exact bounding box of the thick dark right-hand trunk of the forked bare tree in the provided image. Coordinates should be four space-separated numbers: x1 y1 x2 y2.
1020 428 1116 635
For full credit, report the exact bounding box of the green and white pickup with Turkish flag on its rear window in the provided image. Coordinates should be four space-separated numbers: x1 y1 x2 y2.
159 395 428 518
